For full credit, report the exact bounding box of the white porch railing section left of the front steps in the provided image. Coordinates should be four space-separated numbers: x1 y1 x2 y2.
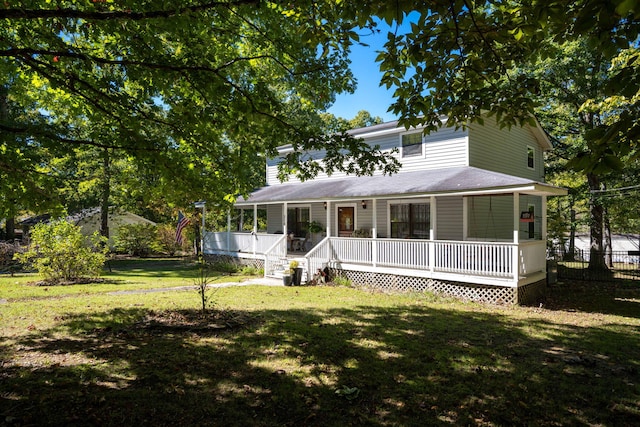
204 231 283 254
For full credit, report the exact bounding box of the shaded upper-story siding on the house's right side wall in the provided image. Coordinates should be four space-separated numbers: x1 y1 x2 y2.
469 118 544 182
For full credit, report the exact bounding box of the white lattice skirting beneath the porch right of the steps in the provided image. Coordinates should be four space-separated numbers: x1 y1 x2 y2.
331 269 546 305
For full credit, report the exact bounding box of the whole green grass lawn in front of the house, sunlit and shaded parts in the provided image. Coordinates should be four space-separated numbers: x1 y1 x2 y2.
0 261 640 426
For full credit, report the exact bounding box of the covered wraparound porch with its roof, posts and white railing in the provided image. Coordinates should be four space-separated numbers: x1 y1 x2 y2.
212 167 566 302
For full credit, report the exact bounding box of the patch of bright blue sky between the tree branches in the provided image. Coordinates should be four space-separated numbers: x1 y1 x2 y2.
328 21 406 122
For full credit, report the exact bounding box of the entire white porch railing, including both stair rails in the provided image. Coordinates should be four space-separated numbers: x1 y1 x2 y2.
205 232 546 287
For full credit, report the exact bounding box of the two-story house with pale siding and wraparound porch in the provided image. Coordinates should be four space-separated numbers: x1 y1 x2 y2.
205 119 566 303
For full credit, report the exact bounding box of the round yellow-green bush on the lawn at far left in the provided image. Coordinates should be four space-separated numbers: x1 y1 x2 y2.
16 220 108 283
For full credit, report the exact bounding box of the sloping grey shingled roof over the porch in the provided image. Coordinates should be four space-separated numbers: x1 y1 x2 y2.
236 167 567 205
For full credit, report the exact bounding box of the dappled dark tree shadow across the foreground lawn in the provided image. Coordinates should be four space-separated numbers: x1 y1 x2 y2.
0 306 640 426
